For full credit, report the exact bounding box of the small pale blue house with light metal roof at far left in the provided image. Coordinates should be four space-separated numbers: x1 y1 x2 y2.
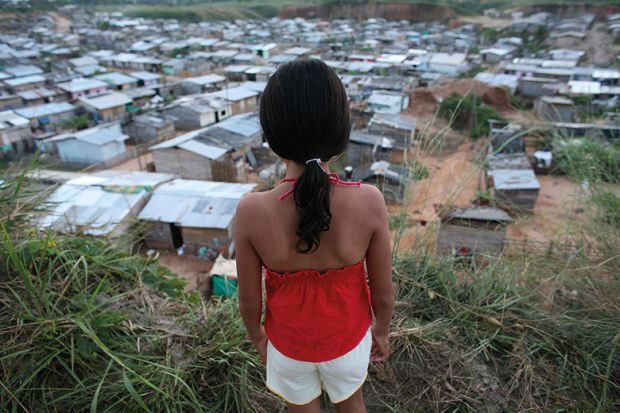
45 123 129 166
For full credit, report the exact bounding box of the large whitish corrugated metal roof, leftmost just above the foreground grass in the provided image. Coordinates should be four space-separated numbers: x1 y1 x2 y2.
37 171 173 237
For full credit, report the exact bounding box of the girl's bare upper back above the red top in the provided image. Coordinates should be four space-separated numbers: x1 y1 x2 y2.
239 182 386 272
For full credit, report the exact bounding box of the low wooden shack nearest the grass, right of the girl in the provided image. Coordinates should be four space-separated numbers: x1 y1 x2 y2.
437 206 512 256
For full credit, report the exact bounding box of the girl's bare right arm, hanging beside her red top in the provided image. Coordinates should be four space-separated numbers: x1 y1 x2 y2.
366 188 394 361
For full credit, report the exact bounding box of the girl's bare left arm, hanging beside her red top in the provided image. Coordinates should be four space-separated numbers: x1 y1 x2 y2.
235 195 266 361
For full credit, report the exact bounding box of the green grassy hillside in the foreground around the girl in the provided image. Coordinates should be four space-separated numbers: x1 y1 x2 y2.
0 131 620 412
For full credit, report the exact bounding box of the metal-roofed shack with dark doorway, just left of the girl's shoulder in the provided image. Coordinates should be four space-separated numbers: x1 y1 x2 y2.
138 179 255 256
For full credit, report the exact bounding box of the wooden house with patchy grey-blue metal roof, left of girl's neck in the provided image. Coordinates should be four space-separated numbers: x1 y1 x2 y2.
150 114 262 182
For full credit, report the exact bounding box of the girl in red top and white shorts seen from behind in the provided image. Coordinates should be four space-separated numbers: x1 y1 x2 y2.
235 59 394 412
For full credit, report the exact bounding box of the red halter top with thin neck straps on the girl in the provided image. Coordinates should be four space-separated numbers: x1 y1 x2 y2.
265 174 372 363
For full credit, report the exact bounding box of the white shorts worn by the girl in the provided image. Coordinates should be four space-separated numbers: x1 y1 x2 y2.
266 329 372 405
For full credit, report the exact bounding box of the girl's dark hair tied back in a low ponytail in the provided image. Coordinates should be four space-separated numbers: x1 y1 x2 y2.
260 59 351 254
